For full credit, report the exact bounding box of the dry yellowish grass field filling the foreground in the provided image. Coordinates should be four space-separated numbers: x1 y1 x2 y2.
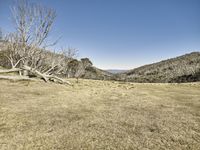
0 80 200 150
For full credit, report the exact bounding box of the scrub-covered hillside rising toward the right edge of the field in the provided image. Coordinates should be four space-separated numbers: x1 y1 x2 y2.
115 52 200 83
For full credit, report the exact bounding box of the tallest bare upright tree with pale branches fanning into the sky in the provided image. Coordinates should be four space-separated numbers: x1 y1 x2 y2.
11 0 56 75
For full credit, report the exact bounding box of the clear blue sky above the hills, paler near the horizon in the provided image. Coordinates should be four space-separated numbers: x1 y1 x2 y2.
0 0 200 69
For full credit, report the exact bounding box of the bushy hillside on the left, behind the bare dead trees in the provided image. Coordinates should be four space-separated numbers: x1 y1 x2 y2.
0 41 113 80
